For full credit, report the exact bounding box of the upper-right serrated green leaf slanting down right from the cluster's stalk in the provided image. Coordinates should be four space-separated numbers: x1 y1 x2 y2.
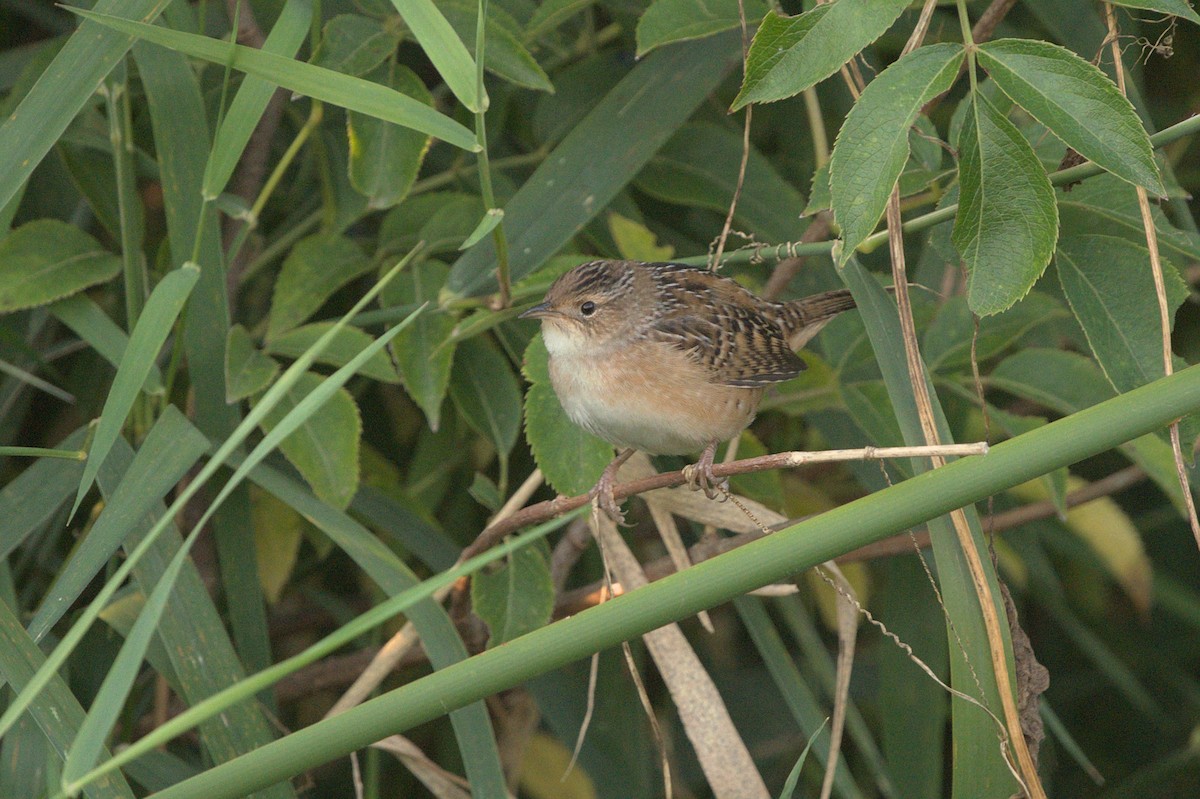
979 38 1166 196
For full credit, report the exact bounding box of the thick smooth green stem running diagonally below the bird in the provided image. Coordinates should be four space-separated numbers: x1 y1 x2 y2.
152 366 1200 799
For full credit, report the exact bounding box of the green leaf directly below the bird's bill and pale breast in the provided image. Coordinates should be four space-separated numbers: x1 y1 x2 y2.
522 328 612 495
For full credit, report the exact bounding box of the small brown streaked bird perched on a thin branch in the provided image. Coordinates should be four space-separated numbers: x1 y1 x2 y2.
521 260 854 521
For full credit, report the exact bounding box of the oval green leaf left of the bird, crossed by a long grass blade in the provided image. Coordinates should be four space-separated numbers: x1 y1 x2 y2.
262 373 362 510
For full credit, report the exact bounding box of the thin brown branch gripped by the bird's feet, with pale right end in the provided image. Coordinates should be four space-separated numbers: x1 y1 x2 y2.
460 444 988 563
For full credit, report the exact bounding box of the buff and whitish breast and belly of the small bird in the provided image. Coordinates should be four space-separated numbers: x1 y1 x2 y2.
547 331 762 455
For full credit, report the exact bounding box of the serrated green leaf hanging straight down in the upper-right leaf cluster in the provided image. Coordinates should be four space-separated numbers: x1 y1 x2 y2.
953 92 1058 317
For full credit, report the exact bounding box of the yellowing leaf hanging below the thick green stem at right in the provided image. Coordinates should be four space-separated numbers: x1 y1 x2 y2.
1009 475 1154 613
